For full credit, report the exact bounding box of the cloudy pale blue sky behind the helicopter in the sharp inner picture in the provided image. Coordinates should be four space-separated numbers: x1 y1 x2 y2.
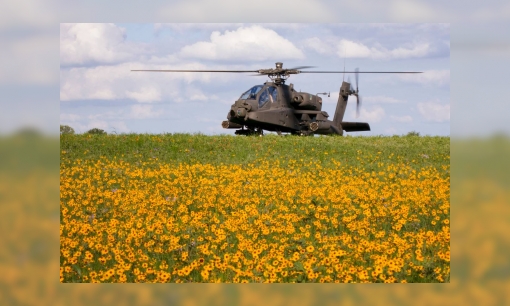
59 23 450 135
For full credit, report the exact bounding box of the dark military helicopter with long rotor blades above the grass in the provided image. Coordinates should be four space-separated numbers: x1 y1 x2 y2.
131 62 421 136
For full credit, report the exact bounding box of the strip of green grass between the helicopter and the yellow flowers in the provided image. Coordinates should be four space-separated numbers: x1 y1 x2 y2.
60 134 450 169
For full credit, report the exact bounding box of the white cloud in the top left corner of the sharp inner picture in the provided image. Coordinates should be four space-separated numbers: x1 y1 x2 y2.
60 23 147 65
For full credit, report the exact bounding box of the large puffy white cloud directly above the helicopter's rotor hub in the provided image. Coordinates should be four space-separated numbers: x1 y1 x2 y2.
180 25 304 61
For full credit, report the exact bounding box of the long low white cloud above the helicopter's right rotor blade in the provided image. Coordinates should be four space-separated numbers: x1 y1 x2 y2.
336 39 433 60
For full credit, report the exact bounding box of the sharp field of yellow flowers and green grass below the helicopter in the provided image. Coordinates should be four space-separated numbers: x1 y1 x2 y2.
60 135 450 283
